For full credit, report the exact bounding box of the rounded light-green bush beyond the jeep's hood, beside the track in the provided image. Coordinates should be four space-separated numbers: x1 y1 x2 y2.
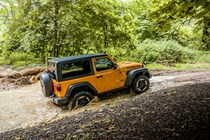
121 40 196 63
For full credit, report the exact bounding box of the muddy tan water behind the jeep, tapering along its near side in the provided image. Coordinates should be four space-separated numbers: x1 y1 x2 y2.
0 83 131 133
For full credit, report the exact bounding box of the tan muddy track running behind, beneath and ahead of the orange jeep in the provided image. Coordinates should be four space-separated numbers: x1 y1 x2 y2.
0 70 210 135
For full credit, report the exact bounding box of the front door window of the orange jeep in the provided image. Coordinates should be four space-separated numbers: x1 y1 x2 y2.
94 58 114 71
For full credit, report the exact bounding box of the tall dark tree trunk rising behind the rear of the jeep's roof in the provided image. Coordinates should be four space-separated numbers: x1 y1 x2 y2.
52 0 59 57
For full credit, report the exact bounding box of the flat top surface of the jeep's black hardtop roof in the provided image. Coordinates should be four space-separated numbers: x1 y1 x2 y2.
49 53 108 63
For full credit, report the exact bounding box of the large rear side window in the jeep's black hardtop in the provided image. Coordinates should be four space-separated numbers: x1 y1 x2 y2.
61 60 91 78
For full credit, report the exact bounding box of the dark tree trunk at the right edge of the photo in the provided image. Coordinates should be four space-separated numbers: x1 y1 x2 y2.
202 18 210 51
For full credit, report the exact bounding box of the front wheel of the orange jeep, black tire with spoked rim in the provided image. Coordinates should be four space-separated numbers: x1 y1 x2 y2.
132 75 150 94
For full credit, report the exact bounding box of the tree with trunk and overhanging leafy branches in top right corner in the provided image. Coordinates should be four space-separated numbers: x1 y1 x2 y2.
150 0 210 50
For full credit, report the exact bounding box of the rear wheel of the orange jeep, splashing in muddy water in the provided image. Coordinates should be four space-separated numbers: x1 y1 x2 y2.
68 91 93 110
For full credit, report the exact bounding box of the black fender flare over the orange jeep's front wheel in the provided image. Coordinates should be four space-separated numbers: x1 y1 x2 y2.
125 68 151 86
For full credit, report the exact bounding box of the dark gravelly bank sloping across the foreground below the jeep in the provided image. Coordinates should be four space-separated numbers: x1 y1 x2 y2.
0 82 210 140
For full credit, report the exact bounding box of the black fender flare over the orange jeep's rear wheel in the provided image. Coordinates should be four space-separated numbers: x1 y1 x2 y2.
65 82 98 99
